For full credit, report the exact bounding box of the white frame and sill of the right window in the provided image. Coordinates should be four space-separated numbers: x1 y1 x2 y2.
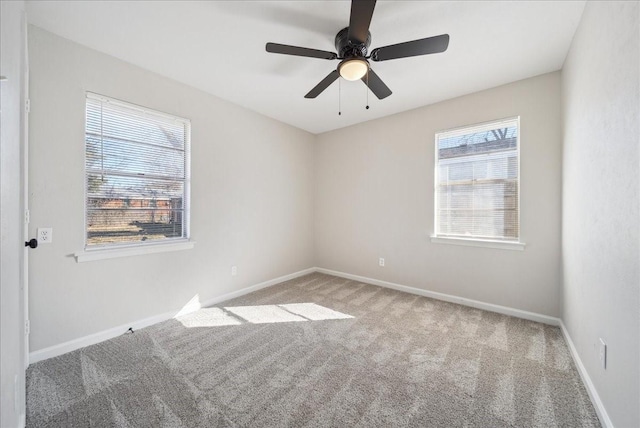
430 116 526 251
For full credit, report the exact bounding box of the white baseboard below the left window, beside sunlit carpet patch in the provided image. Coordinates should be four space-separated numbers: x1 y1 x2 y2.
29 268 316 364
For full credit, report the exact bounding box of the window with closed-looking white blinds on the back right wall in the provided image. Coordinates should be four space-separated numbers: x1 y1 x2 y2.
435 118 520 242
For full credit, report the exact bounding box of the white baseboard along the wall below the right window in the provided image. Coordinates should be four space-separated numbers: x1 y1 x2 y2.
316 268 561 326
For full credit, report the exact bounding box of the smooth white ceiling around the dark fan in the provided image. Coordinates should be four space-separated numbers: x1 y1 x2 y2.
27 0 585 133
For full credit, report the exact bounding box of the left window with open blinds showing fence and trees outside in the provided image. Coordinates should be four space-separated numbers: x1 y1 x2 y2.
85 93 190 248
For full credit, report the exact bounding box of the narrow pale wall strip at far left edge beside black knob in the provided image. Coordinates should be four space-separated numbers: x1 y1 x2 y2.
0 1 25 427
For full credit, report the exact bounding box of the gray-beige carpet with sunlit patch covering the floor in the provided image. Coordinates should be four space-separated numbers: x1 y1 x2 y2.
27 273 600 428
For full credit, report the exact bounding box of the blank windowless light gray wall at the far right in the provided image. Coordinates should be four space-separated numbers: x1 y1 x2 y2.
562 2 640 427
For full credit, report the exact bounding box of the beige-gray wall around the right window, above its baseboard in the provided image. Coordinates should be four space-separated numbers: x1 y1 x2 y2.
315 72 561 316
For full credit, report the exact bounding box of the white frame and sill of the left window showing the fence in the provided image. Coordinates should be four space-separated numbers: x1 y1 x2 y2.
74 92 195 263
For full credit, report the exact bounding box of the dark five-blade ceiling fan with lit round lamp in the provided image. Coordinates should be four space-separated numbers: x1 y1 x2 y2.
266 0 449 99
